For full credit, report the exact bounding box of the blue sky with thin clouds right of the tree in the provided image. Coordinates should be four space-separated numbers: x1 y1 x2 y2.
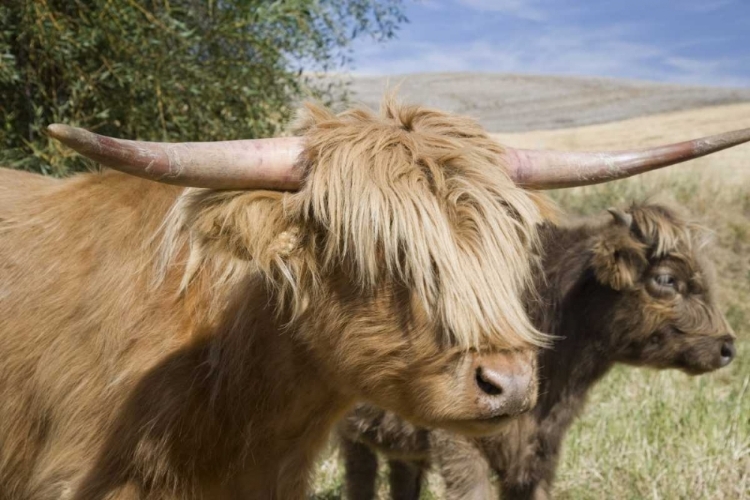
353 0 750 87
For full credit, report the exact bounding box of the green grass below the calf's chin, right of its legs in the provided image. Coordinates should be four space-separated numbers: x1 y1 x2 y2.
555 350 750 499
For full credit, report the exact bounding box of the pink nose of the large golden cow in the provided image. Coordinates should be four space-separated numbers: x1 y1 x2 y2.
474 353 537 416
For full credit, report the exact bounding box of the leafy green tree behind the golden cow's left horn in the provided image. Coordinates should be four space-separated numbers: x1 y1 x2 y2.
0 0 405 175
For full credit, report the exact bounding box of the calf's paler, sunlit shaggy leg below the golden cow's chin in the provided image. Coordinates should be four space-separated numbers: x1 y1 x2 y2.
430 431 492 500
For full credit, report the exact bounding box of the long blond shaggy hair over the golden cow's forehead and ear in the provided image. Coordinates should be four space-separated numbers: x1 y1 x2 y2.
165 96 553 349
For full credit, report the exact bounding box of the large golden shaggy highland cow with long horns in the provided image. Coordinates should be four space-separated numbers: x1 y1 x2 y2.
0 94 750 500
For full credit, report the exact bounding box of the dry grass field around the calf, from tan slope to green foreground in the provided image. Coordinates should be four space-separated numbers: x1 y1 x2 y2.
314 104 750 500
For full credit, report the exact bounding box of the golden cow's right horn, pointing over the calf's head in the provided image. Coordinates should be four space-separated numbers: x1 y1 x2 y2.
505 128 750 189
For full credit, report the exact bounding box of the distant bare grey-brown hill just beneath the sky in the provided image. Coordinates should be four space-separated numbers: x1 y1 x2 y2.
351 73 750 132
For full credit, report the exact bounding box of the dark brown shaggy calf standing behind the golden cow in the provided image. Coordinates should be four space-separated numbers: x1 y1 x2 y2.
340 204 735 500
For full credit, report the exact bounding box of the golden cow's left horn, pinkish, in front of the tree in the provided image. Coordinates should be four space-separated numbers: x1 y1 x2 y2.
47 124 302 190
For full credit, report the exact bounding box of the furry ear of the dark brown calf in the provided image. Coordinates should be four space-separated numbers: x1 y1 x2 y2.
592 213 648 290
